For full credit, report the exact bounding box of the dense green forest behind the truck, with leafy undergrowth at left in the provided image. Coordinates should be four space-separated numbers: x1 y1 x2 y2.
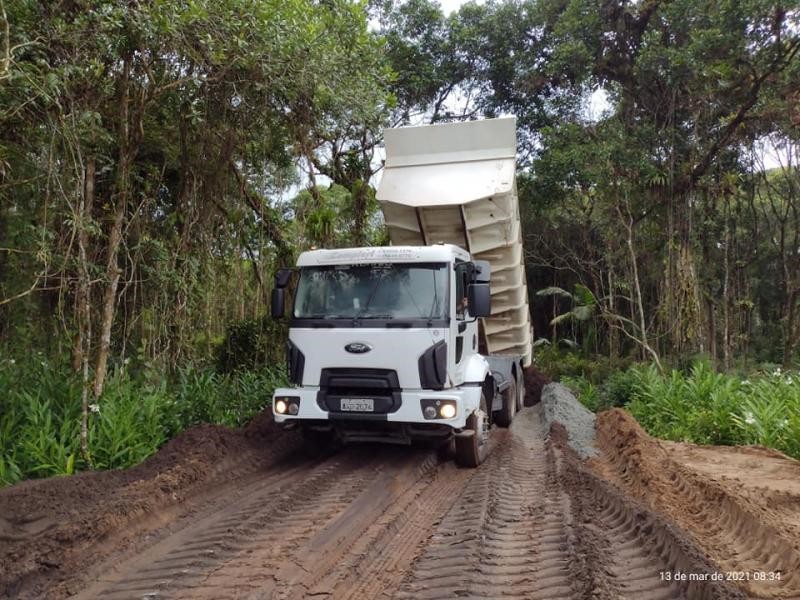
0 0 800 482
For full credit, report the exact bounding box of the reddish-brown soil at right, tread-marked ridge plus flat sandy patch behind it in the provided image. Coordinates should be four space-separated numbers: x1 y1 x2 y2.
592 409 800 598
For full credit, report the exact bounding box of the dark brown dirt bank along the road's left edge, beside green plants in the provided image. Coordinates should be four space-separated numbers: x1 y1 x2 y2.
0 410 296 597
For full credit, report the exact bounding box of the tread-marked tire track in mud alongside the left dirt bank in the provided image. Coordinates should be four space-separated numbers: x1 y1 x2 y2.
77 456 386 600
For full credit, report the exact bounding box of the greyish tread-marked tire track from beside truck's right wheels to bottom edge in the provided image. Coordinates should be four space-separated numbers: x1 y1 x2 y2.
397 409 580 600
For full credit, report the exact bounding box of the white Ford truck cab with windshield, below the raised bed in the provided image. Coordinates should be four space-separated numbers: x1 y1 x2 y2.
273 244 506 464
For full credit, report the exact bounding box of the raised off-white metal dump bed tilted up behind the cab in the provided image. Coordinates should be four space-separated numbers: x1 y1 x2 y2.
377 117 532 366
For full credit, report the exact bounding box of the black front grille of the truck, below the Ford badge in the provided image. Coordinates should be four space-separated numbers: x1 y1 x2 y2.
317 368 401 415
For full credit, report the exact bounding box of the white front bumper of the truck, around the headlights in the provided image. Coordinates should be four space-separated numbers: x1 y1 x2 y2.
272 385 481 429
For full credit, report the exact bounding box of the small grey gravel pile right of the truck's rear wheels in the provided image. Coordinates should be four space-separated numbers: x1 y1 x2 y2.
542 383 597 458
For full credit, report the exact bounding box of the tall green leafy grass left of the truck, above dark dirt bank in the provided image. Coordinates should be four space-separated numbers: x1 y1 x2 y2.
0 358 283 486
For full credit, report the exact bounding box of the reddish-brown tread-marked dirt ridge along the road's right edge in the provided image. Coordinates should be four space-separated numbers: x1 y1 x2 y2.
591 409 800 598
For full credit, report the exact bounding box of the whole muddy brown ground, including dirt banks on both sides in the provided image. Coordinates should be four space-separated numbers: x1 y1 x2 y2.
0 390 800 600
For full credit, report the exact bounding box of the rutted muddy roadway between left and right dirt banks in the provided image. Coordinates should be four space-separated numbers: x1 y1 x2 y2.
72 407 742 600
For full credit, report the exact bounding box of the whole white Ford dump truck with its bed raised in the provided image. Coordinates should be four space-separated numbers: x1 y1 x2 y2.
272 118 532 467
